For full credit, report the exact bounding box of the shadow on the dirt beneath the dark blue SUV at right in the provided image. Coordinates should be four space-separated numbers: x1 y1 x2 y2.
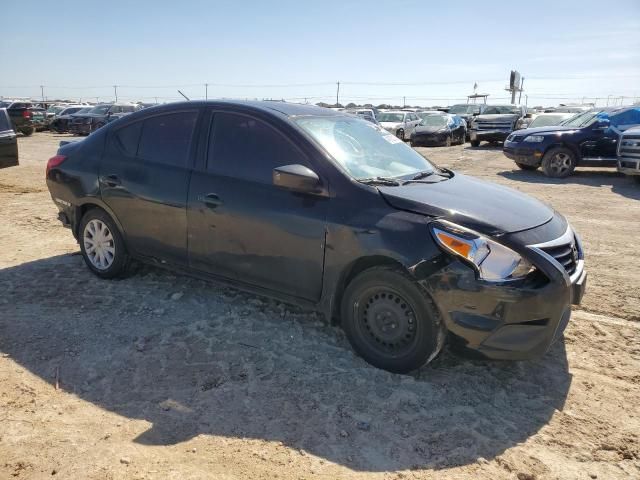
498 168 640 200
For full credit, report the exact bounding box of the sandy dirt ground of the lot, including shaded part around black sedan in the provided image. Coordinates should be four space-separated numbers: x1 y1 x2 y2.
0 133 640 480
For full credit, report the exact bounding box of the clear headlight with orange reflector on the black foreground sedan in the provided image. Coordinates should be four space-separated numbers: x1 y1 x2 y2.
431 222 535 282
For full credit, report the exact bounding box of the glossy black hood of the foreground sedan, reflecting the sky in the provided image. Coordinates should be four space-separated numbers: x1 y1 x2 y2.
378 173 554 235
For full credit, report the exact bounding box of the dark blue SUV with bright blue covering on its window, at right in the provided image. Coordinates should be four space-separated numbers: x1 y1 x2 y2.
503 106 640 178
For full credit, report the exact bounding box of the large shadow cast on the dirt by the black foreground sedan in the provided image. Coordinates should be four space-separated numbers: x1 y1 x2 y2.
0 254 571 472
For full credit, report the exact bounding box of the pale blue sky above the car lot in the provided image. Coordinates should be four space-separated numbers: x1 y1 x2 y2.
0 0 640 105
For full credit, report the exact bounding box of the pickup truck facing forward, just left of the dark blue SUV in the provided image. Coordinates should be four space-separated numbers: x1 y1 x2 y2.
469 105 526 147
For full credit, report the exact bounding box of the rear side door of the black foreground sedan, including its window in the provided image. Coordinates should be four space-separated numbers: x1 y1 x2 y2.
99 109 199 264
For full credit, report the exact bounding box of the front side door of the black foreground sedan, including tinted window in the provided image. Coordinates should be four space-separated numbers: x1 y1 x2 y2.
188 111 328 301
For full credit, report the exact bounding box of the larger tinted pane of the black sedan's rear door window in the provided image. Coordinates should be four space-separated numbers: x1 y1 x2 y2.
138 112 198 166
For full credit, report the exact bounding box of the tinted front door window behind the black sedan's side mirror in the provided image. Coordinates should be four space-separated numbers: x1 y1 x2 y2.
207 113 306 183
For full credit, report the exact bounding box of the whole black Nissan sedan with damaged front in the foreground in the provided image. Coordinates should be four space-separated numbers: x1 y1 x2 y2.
46 101 586 372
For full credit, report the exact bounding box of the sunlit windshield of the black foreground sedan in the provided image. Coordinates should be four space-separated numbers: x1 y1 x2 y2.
296 117 435 179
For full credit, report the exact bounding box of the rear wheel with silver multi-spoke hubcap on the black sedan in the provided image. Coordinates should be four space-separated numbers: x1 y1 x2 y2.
78 208 130 278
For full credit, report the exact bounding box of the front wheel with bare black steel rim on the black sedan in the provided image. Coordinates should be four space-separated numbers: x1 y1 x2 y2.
341 266 444 373
